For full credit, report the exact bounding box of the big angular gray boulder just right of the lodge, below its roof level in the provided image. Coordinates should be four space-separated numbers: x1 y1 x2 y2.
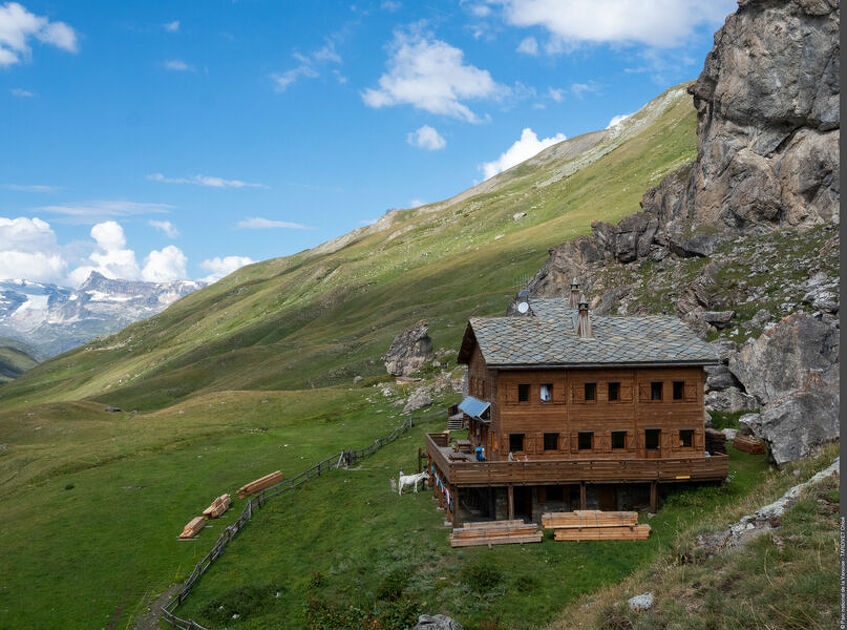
729 313 840 404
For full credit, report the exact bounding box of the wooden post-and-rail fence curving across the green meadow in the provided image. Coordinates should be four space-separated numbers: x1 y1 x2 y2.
162 411 434 630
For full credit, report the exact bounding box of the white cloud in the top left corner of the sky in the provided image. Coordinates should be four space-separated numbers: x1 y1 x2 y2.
0 2 79 66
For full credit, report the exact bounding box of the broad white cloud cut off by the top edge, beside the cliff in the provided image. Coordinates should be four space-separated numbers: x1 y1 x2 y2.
502 0 736 52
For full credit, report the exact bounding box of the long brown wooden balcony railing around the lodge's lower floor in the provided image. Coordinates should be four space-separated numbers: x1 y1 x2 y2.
426 433 729 487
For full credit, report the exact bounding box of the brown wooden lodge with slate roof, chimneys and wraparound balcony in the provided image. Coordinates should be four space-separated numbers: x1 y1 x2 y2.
426 280 728 525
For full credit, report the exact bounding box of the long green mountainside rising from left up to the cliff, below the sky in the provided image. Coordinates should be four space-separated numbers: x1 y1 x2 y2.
0 88 696 410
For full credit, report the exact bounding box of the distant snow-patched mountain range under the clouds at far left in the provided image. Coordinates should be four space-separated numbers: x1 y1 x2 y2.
0 271 205 355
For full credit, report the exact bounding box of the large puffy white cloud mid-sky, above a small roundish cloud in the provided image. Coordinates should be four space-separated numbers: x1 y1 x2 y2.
362 28 509 122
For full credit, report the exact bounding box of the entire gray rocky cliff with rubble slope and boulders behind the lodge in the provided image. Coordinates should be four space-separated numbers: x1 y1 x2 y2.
528 0 840 463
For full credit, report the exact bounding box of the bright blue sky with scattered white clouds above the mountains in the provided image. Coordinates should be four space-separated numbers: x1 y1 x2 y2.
0 0 735 284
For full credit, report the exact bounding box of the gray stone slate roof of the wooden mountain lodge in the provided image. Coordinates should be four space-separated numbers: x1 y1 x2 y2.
463 298 718 367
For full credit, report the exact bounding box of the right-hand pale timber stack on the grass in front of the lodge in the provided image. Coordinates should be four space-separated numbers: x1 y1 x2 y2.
541 510 650 541
